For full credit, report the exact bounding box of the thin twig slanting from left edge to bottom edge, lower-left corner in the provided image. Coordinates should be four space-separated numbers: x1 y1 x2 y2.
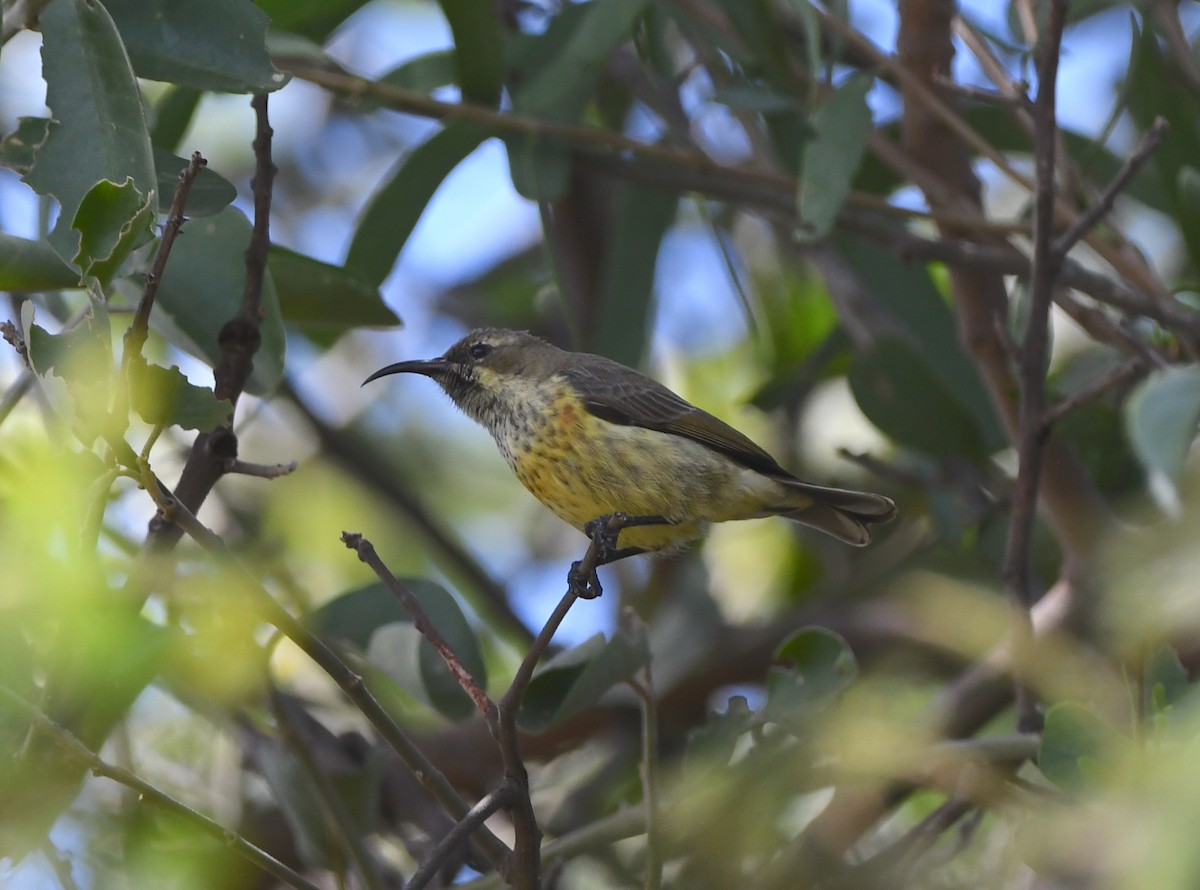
0 686 319 890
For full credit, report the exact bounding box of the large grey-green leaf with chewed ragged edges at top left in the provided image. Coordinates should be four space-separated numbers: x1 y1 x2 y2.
25 0 157 258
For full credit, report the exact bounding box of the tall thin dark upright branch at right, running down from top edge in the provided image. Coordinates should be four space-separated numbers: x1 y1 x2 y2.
1003 0 1067 732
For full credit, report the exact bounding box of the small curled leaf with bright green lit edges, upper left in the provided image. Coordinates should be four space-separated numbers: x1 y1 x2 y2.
71 178 155 281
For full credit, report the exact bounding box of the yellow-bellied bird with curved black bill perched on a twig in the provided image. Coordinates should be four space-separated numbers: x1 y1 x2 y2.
362 327 896 591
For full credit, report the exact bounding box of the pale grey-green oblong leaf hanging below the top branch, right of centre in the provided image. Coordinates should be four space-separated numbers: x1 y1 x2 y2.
797 74 875 241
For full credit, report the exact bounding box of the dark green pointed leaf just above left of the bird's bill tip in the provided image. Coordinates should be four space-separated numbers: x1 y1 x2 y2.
268 245 400 333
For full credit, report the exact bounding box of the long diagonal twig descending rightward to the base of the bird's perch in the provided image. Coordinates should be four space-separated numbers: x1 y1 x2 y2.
153 483 510 871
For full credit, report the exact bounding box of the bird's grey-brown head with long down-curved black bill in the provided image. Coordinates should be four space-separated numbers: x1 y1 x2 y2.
362 327 566 432
